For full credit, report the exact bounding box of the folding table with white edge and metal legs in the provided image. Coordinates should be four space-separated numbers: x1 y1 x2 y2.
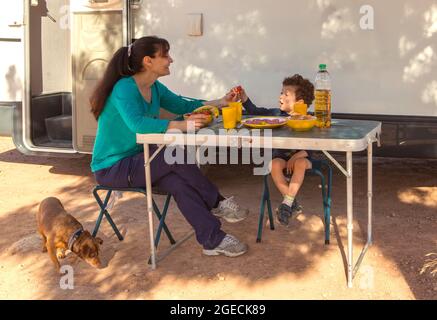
137 119 381 287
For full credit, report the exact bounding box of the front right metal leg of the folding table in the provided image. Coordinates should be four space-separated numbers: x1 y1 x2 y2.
346 151 354 288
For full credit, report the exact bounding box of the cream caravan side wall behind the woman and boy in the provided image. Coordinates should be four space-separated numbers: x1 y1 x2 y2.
135 0 437 116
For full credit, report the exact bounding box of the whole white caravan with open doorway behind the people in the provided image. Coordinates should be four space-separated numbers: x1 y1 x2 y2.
0 0 437 158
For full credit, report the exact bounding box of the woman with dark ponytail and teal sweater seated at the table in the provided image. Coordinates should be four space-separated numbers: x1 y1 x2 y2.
90 36 247 257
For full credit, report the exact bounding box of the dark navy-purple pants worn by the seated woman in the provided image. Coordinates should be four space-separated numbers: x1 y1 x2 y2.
94 145 225 249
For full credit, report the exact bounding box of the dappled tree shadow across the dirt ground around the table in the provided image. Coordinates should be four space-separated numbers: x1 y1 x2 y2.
0 151 437 299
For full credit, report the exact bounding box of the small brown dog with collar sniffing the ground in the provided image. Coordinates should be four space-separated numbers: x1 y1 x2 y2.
36 197 103 272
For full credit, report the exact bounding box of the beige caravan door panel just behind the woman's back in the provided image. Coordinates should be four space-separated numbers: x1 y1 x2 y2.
71 0 129 153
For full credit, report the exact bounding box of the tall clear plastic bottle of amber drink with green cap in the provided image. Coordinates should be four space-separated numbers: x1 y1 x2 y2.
314 64 331 128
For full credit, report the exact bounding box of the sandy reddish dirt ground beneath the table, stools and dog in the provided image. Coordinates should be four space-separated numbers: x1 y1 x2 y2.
0 137 437 299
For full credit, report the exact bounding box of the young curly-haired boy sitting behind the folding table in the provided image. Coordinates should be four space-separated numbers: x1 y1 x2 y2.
231 74 314 226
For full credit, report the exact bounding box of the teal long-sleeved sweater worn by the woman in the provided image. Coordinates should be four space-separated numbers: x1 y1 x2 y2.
91 77 202 172
